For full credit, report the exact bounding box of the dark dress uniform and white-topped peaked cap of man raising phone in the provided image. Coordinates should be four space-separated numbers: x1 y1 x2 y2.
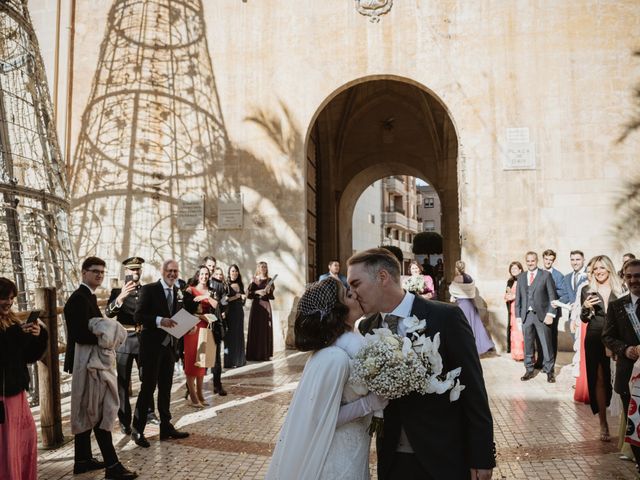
105 257 144 434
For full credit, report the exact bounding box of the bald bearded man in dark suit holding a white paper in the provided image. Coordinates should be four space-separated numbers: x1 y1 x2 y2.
131 260 191 448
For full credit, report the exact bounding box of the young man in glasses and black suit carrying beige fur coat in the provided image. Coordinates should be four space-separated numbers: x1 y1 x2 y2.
64 257 137 479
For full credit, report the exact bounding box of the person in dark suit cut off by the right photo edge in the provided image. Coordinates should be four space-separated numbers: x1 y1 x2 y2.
602 259 640 462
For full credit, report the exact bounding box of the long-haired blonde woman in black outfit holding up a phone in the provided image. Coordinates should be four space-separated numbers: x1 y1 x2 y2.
580 255 623 442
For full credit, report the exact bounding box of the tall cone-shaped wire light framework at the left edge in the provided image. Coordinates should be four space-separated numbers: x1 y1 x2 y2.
0 0 76 310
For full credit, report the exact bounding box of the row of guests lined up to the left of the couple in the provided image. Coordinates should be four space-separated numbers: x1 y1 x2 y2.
0 256 275 480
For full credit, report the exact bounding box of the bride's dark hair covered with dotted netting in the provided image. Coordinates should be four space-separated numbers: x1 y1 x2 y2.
294 277 349 352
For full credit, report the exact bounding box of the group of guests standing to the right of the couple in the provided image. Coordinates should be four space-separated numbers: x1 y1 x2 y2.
504 250 640 459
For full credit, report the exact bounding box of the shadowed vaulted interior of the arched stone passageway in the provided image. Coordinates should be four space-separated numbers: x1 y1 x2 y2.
306 76 460 281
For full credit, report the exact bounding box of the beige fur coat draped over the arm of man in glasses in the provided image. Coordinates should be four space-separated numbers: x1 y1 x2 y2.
71 317 127 435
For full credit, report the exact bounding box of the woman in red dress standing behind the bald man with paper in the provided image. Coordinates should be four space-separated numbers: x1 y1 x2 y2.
184 265 214 408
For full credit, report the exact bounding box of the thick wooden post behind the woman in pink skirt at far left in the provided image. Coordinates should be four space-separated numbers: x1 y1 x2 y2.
36 288 64 448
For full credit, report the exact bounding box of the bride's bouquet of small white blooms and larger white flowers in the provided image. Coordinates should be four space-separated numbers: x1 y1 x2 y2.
350 316 464 433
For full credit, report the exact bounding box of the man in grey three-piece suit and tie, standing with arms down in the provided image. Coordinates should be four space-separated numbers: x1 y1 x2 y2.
516 252 558 383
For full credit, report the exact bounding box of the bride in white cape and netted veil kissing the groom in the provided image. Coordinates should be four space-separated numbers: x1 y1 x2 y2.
266 277 387 480
